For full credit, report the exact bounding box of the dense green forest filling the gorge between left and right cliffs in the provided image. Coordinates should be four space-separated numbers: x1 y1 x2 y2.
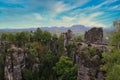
0 28 80 80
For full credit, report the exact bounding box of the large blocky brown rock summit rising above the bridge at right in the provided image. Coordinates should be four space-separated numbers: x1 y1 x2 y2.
84 28 103 44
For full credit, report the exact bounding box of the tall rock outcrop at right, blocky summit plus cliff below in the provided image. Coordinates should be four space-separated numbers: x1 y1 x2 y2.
77 28 106 80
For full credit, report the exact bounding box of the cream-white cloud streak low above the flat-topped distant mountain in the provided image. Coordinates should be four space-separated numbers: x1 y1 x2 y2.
38 12 106 27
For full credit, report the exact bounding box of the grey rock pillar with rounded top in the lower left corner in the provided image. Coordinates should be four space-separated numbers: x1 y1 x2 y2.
4 45 25 80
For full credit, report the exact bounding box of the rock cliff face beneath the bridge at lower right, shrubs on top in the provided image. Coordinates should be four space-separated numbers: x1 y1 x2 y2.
77 48 105 80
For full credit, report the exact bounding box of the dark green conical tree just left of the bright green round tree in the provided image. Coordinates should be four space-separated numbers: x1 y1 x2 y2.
40 50 57 80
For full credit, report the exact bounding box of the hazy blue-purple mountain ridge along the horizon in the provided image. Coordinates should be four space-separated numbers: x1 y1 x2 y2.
0 25 114 34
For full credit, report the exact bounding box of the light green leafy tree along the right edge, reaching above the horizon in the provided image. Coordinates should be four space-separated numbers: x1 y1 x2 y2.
102 20 120 80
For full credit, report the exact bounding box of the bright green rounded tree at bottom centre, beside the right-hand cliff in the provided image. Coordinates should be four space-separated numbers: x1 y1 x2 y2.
53 56 77 80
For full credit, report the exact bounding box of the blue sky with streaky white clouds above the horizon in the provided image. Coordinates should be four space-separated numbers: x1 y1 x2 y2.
0 0 120 29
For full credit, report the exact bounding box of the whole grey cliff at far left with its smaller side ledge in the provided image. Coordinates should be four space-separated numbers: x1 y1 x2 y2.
0 42 39 80
